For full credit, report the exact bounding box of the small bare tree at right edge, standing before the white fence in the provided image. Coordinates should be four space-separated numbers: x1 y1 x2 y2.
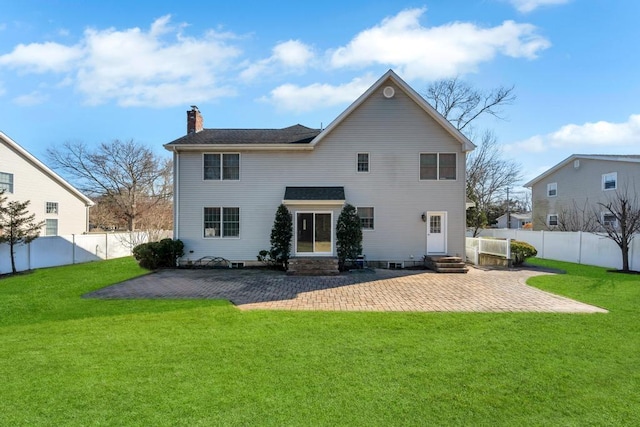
593 186 640 271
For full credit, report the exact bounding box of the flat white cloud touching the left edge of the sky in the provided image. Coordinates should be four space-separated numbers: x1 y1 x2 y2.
0 42 82 73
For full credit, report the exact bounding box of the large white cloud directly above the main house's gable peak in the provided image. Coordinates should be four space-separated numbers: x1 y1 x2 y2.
329 8 551 79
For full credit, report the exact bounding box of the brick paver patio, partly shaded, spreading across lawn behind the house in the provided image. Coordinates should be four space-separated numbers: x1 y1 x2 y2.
84 267 607 313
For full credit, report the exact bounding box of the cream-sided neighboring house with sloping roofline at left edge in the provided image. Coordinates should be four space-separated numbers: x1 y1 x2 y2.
0 132 93 236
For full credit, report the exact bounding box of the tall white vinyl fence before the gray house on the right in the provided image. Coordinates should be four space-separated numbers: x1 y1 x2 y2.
480 229 640 270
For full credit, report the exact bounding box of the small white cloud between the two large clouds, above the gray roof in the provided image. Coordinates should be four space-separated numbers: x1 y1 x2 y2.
240 40 314 80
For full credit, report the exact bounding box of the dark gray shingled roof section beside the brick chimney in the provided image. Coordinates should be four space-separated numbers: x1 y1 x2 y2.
167 125 321 145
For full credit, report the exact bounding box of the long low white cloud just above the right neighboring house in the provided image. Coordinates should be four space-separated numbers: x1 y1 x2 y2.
507 114 640 153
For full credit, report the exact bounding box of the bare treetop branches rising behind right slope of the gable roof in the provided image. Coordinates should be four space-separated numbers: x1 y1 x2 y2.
425 77 516 131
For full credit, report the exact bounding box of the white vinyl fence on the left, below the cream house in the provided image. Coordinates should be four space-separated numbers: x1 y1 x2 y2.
0 231 172 274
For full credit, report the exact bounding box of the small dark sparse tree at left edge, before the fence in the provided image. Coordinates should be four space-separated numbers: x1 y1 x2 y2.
0 190 45 274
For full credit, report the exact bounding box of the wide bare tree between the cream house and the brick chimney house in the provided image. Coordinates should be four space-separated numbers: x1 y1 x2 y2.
47 140 171 231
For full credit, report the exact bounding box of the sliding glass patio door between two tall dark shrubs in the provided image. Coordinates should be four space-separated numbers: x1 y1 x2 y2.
296 212 333 255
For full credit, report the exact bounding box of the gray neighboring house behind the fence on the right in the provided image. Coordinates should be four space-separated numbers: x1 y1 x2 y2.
524 154 640 231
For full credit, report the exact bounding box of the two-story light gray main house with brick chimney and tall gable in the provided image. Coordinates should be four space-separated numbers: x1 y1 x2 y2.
164 70 474 267
